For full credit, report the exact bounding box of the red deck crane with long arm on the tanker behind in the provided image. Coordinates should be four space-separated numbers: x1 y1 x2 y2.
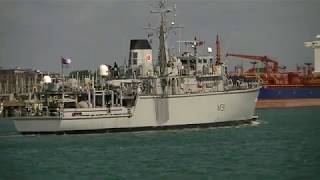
226 53 279 73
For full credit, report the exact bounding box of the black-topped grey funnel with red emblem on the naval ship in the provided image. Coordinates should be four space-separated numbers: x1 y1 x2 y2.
129 39 153 77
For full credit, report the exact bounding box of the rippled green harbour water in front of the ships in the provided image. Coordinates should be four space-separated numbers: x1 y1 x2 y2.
0 107 320 179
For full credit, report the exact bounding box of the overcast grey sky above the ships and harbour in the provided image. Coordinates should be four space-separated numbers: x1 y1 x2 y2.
0 0 320 72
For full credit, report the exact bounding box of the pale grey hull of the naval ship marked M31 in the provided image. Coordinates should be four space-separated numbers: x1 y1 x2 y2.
14 88 259 133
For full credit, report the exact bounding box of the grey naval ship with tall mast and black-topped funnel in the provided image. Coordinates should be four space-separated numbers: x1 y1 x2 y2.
13 1 260 133
